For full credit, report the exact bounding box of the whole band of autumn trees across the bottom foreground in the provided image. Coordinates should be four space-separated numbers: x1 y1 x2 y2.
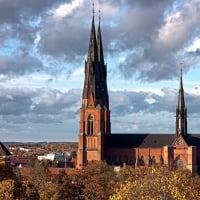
0 161 200 200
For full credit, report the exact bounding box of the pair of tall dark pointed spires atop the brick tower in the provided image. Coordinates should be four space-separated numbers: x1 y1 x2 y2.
82 4 109 108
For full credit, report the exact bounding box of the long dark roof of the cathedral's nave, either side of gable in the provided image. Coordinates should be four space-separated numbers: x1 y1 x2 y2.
107 133 200 148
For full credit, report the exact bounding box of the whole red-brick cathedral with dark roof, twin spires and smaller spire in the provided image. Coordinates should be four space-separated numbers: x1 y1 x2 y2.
77 14 200 173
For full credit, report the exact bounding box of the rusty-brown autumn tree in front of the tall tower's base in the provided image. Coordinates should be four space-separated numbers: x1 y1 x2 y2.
50 161 116 200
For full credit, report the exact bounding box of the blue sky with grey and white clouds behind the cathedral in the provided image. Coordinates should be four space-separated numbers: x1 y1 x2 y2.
0 0 200 142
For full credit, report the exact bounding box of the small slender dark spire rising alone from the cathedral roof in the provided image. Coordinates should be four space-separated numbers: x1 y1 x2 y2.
176 69 187 137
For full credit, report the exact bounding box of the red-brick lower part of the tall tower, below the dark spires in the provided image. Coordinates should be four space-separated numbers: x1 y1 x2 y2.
77 97 110 167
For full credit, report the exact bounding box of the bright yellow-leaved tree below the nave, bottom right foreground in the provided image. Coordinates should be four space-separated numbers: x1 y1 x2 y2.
109 167 200 200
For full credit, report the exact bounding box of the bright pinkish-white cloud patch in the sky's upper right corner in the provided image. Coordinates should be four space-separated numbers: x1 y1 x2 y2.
156 0 200 53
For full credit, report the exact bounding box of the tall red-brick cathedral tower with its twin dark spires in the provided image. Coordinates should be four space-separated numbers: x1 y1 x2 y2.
77 9 110 168
